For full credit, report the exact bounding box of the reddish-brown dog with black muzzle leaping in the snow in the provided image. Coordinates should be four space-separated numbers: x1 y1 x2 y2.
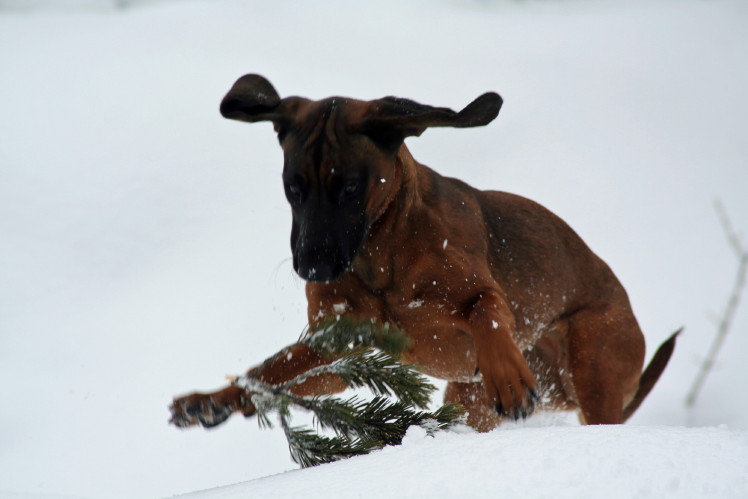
172 75 675 431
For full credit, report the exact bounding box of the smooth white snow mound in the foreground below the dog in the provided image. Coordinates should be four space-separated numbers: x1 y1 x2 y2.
180 426 748 499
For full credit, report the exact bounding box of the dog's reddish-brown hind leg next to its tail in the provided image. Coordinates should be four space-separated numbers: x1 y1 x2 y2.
569 299 644 424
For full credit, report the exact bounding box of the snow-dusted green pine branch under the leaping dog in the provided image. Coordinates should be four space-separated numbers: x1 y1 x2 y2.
237 318 465 468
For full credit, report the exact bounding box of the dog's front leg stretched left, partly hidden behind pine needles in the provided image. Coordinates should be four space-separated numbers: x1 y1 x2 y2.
170 344 345 428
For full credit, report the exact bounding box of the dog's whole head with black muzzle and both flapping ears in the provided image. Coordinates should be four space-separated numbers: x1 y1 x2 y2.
221 75 502 282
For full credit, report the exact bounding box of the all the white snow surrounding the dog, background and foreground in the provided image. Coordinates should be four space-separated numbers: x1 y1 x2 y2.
0 0 748 498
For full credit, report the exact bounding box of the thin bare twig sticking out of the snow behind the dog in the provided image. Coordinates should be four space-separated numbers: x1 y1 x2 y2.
686 201 748 407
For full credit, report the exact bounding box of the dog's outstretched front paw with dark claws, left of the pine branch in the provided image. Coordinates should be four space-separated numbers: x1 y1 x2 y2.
169 386 255 428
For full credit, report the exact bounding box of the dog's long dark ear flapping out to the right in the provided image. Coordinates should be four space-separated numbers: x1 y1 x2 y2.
362 92 503 149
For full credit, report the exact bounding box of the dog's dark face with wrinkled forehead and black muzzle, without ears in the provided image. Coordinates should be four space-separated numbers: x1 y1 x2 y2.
278 98 394 282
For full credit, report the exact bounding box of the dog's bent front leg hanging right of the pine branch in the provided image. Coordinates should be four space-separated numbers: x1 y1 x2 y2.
470 291 537 419
